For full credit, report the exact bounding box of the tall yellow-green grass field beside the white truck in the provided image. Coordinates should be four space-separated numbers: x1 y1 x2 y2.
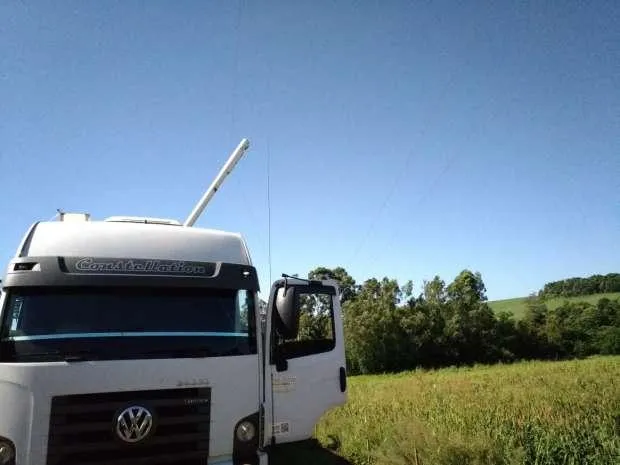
316 357 620 465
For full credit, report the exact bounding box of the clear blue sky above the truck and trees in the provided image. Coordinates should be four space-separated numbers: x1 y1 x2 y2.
0 0 620 299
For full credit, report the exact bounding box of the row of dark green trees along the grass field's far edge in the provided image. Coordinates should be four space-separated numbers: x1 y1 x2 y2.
300 267 620 374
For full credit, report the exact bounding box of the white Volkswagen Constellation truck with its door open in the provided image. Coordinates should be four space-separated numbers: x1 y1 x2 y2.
0 139 347 465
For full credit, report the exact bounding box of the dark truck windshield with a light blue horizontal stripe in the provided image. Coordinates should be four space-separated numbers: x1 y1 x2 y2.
0 287 256 361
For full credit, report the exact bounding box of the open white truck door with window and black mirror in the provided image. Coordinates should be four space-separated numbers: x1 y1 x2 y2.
265 277 347 444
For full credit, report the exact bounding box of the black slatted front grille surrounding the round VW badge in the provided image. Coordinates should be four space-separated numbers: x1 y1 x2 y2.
47 388 211 465
